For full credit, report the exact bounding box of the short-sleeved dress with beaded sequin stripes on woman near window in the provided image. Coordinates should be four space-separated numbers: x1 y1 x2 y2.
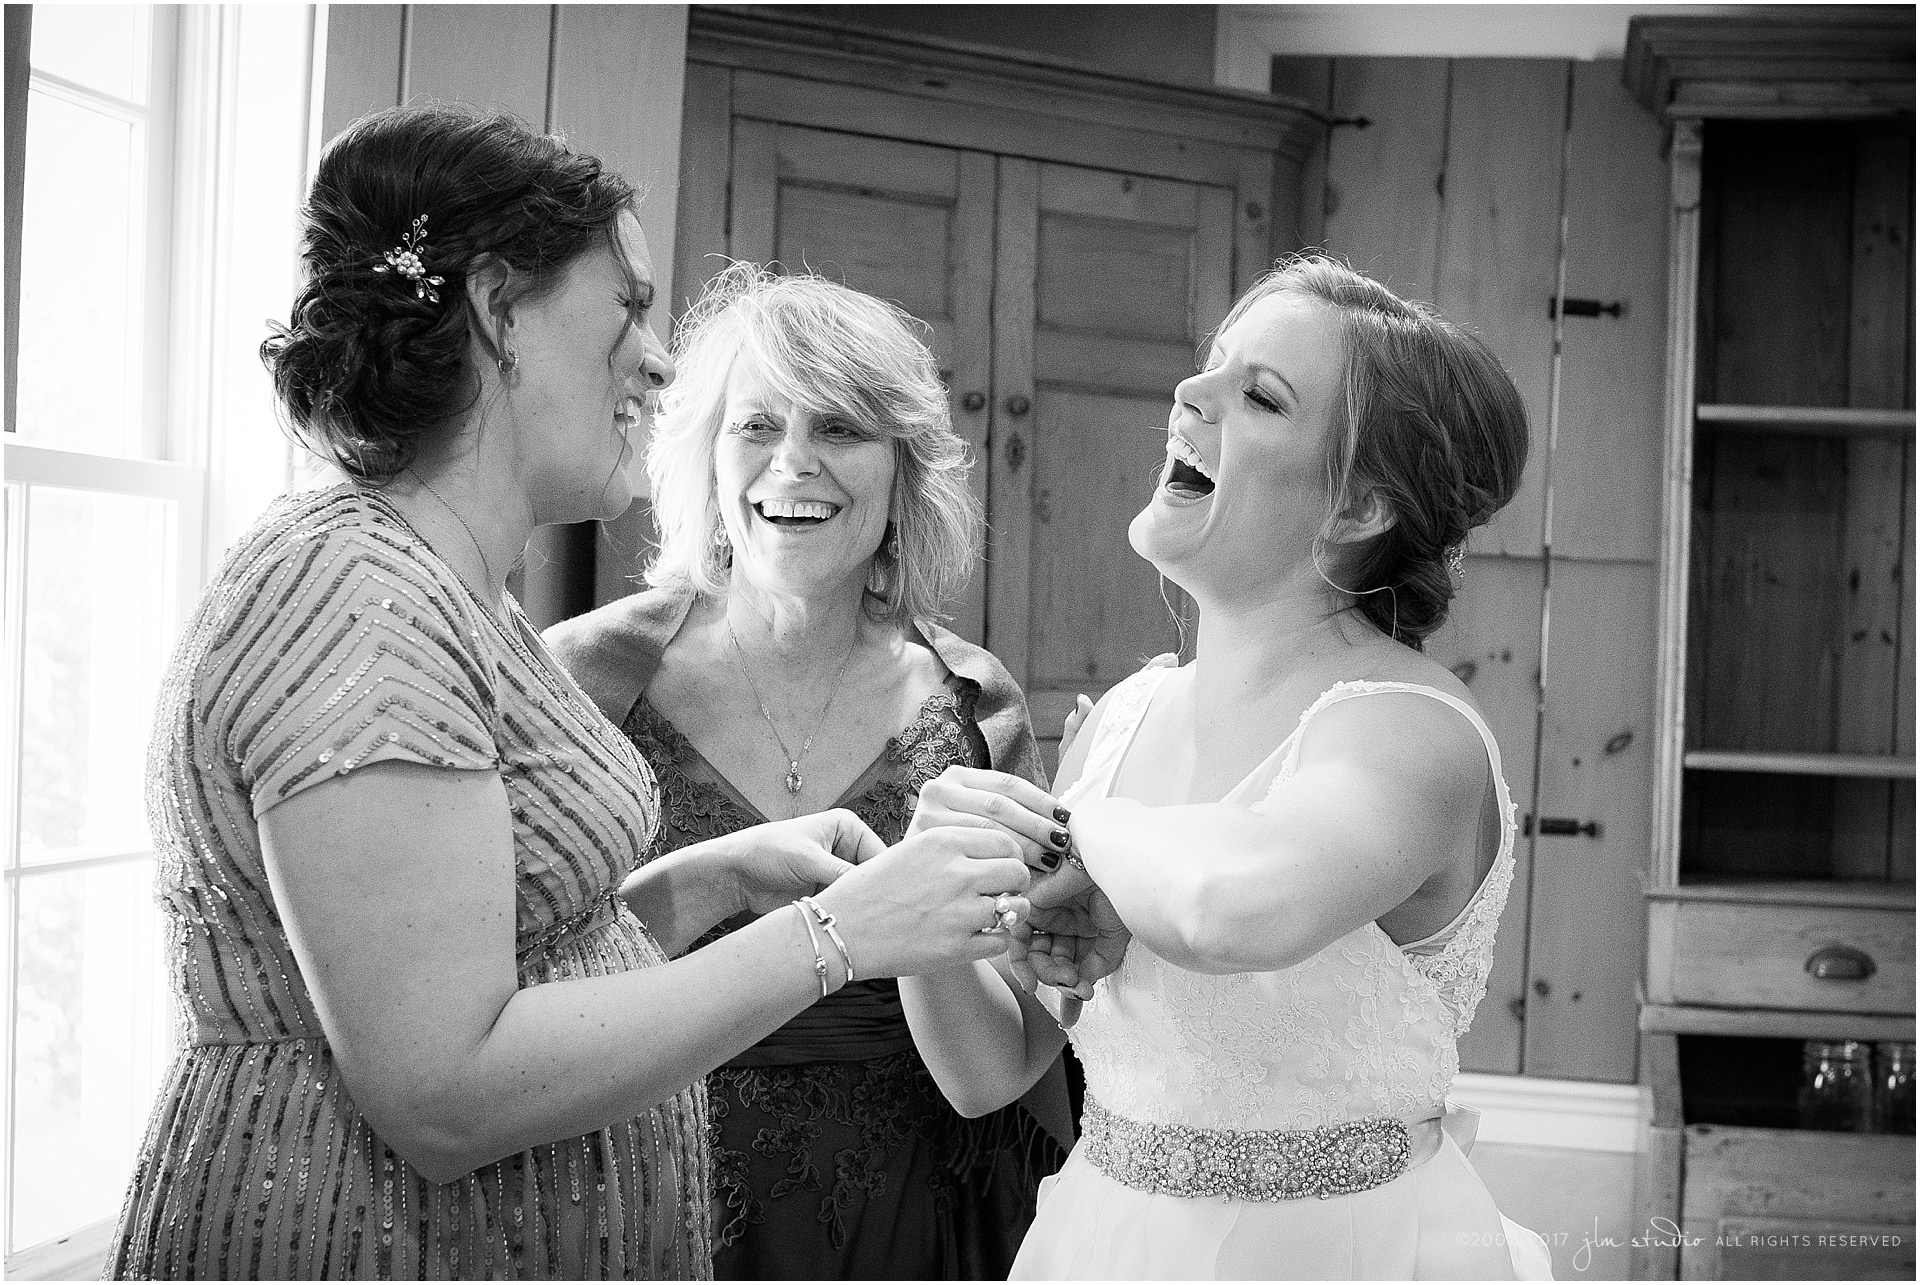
108 486 710 1279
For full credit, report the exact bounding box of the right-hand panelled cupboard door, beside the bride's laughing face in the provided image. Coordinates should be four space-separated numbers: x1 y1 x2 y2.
987 158 1235 736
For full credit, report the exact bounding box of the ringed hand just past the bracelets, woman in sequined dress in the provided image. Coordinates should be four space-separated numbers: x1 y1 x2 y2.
814 826 1033 978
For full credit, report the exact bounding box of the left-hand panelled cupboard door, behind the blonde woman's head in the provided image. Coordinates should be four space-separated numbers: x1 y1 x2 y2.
728 119 995 642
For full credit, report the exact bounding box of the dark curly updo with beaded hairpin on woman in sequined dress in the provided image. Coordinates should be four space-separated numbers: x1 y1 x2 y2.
259 104 634 484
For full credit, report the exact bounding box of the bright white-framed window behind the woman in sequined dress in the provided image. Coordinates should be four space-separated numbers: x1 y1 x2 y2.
0 6 313 1277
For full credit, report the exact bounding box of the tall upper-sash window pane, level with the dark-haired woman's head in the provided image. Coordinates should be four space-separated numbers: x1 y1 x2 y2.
15 92 142 455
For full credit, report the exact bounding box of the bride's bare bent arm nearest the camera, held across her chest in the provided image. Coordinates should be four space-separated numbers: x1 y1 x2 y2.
1073 695 1488 974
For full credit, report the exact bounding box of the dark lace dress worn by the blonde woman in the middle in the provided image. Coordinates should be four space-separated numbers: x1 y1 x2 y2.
624 678 1062 1279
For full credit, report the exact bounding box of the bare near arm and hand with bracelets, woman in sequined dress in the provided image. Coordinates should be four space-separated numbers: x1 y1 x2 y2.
261 763 1027 1181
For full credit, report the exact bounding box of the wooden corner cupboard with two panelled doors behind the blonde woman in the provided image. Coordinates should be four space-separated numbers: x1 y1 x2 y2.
674 8 1323 752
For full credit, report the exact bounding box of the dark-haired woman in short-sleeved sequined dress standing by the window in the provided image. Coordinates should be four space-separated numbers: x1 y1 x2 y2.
109 106 1027 1279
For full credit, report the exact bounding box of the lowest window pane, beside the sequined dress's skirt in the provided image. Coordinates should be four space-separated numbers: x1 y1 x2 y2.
8 861 167 1252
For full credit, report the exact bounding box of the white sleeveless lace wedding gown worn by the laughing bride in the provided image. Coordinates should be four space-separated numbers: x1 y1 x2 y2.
1012 665 1551 1279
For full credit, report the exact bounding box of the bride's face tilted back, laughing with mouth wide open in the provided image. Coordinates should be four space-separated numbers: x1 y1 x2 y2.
1129 290 1346 597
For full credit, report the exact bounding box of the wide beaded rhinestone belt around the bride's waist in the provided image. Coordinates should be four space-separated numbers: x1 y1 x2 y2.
1081 1097 1413 1200
